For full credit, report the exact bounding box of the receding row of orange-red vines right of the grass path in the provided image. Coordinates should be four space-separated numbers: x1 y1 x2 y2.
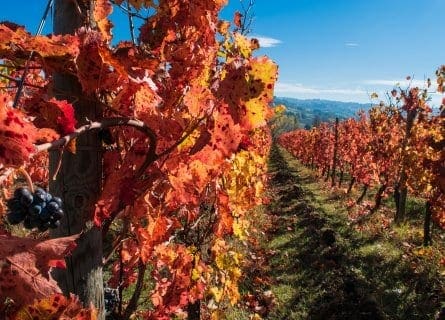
279 75 445 244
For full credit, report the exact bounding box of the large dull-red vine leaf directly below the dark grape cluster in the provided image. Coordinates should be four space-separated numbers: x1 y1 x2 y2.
0 235 78 305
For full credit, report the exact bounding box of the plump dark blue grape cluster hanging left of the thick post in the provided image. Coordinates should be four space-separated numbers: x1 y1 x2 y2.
7 188 63 232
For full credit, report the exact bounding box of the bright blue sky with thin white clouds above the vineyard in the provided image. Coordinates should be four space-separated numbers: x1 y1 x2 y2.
0 0 445 104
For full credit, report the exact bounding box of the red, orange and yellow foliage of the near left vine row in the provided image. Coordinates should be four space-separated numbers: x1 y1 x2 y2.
0 0 277 319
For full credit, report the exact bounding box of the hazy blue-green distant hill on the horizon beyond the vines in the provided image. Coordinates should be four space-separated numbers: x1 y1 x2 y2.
274 97 371 128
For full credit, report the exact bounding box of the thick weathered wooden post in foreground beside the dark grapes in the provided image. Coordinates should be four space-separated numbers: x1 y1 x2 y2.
50 0 105 319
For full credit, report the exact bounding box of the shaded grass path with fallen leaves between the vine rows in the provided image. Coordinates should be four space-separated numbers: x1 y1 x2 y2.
267 147 445 320
